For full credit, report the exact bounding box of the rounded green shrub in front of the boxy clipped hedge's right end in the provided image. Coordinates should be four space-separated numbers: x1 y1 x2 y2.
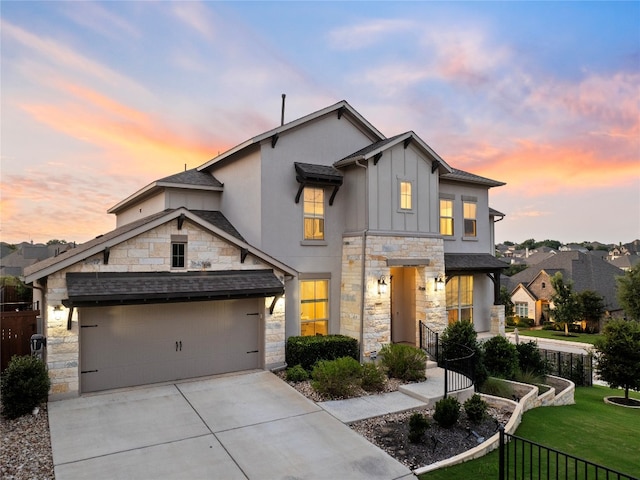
311 357 362 398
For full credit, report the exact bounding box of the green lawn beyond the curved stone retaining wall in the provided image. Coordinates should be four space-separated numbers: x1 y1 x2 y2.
420 386 640 480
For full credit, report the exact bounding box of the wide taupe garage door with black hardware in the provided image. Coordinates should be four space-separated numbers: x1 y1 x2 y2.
79 299 261 392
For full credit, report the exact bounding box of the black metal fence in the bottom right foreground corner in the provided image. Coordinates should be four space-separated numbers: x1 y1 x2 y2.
498 426 639 480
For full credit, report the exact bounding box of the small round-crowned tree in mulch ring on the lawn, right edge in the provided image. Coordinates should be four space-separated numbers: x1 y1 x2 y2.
595 320 640 401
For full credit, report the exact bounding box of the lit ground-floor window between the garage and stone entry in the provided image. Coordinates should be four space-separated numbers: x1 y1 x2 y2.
300 280 329 335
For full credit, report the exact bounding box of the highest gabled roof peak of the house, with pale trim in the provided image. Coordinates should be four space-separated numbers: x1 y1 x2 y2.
197 100 385 171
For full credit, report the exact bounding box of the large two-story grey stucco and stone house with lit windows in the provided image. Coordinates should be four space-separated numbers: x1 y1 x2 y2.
25 101 506 398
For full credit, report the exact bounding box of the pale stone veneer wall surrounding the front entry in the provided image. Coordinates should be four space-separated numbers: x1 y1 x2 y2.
340 234 447 357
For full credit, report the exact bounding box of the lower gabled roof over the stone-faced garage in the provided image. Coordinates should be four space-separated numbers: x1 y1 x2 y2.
24 207 296 283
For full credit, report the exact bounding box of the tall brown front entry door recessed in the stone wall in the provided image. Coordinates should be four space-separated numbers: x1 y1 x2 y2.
391 267 416 345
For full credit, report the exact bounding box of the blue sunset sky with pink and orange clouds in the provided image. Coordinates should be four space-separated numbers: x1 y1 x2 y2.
0 0 640 248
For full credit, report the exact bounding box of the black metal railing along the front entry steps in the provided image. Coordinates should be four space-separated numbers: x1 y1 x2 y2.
420 322 476 398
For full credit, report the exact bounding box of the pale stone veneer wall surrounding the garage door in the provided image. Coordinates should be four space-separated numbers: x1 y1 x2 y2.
45 221 285 400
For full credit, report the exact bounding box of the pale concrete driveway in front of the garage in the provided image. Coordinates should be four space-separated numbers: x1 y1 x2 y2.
49 371 413 480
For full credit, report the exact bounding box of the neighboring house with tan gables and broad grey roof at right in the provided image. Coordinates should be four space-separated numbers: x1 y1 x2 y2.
508 251 624 325
